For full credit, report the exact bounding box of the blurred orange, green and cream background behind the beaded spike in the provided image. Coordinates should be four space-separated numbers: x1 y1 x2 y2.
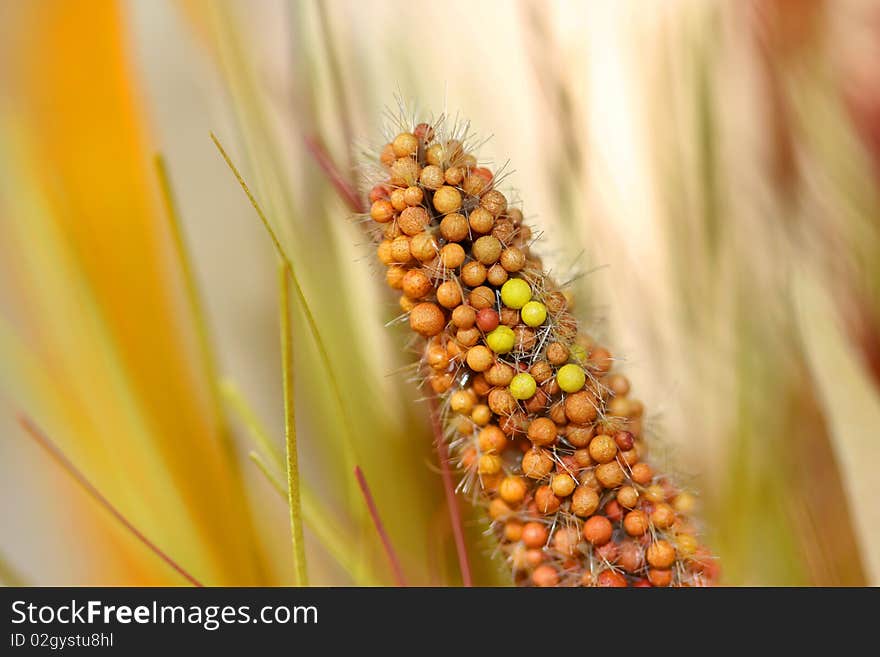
0 0 880 585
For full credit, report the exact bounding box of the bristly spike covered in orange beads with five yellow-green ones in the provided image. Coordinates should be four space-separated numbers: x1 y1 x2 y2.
370 123 715 586
